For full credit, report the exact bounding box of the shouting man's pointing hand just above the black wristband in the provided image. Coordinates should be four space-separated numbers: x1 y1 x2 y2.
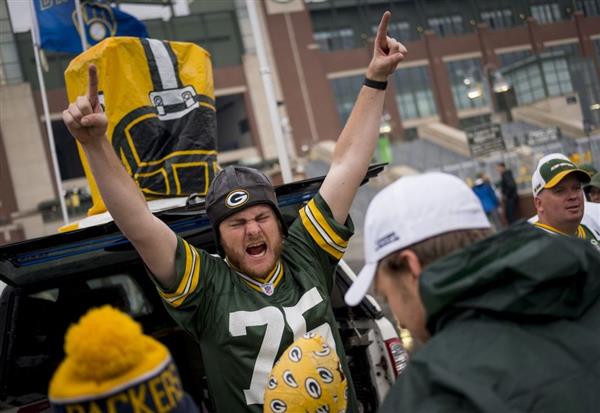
367 11 407 82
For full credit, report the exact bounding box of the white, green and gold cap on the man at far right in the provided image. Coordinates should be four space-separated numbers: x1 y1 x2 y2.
531 153 590 196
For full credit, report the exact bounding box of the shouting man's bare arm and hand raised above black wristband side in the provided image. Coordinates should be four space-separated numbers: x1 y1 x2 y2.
319 11 406 223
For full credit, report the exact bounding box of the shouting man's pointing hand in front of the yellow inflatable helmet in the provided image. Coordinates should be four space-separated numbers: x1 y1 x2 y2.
63 64 108 145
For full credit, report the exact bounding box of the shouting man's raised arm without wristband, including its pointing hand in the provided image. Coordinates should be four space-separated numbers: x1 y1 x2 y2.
63 65 177 287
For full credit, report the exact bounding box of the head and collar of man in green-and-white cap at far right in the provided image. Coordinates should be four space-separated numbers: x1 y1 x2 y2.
531 153 600 251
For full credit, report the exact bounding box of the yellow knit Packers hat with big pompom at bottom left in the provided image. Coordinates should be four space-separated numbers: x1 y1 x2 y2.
48 305 198 413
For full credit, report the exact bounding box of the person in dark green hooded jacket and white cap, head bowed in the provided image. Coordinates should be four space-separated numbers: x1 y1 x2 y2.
346 173 600 413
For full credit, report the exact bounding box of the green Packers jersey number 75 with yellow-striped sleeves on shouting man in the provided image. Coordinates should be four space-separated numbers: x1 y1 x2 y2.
154 194 356 412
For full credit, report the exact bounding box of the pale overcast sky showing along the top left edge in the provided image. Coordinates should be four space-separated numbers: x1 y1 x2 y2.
7 0 189 33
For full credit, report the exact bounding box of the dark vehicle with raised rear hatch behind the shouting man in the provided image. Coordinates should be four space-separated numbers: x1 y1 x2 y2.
0 166 406 413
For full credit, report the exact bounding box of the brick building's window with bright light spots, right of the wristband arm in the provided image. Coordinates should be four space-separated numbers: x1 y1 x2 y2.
446 59 490 110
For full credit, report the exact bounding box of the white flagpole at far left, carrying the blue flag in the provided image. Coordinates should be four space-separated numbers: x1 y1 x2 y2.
29 0 69 225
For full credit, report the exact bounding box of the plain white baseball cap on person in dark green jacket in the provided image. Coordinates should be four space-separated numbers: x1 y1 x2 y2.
345 172 490 306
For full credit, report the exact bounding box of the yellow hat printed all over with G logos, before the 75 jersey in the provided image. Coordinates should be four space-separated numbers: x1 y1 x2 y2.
263 334 348 413
